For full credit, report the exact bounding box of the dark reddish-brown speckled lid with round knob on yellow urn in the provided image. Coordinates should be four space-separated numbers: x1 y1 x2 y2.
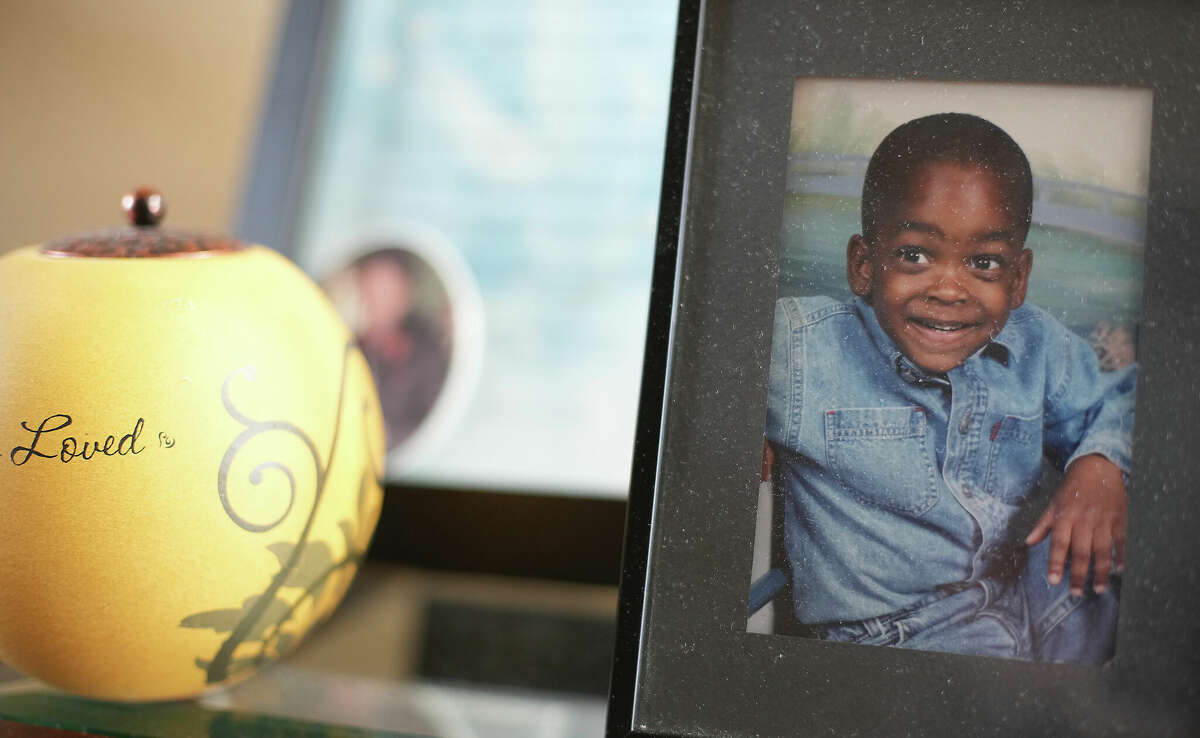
42 187 245 258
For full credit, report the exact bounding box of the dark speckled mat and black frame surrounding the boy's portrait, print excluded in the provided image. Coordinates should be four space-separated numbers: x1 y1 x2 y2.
607 0 1200 737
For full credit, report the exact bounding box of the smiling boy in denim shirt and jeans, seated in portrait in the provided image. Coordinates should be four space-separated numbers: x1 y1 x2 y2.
767 113 1135 662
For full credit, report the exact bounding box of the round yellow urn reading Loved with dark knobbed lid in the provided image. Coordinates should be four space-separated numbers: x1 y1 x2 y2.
0 191 384 700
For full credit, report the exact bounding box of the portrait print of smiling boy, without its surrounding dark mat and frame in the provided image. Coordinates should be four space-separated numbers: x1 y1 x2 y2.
749 79 1151 664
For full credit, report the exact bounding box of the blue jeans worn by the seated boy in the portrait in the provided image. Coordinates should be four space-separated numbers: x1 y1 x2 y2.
809 539 1120 664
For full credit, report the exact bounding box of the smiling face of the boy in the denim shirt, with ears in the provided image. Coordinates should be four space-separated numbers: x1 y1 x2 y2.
846 162 1033 373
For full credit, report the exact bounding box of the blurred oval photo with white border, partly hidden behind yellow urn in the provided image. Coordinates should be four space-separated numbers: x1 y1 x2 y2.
322 230 482 476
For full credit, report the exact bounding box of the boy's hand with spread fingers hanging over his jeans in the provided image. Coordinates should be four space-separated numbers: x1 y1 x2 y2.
1025 454 1126 596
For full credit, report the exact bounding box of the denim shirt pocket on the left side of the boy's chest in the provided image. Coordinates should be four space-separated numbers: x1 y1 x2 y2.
826 407 937 516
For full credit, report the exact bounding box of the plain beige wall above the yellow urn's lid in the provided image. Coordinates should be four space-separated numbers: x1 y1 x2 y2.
0 0 283 252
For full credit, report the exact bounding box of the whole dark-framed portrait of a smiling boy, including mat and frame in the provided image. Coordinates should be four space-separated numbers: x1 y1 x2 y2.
608 0 1200 736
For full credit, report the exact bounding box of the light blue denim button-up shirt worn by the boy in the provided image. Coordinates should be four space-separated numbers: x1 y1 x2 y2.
767 298 1136 624
